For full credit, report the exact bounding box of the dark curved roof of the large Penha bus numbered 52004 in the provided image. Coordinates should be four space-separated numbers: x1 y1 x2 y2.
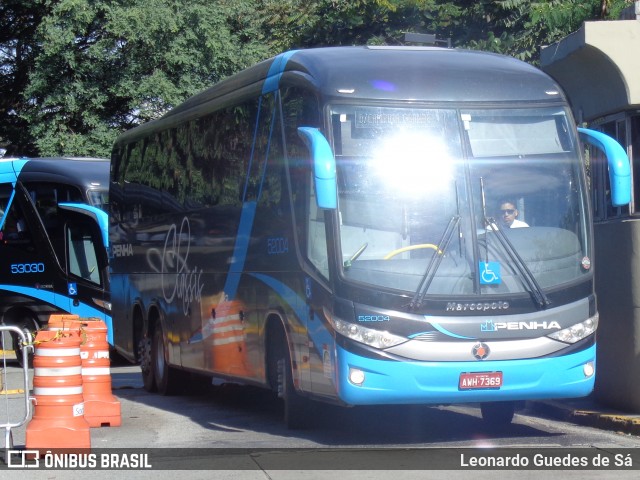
115 46 565 144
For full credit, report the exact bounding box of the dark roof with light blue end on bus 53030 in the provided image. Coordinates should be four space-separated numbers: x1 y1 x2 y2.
0 157 110 189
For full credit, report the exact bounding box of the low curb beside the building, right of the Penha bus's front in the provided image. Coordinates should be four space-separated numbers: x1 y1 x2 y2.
527 400 640 435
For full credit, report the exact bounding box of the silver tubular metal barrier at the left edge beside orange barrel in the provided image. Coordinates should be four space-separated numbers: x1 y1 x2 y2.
0 325 33 464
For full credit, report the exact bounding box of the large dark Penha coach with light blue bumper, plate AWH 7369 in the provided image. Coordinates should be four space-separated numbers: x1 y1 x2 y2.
109 47 629 427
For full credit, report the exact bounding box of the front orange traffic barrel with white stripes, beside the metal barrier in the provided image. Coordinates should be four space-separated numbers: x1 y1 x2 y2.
25 330 91 451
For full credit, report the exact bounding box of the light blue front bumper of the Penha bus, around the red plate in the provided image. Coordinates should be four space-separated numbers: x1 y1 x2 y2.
336 344 596 405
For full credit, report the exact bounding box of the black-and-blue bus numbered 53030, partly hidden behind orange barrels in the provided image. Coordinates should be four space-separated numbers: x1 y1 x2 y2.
0 158 111 360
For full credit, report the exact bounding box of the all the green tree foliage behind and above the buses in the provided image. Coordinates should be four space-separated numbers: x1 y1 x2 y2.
0 0 630 156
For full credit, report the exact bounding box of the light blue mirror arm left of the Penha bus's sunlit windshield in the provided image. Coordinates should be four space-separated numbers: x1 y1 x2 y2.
298 127 338 209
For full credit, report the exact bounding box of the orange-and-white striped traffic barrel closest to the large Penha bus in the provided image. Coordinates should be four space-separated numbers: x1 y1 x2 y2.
80 319 122 427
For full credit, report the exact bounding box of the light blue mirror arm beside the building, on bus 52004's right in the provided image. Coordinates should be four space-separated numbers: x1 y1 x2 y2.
578 128 631 207
